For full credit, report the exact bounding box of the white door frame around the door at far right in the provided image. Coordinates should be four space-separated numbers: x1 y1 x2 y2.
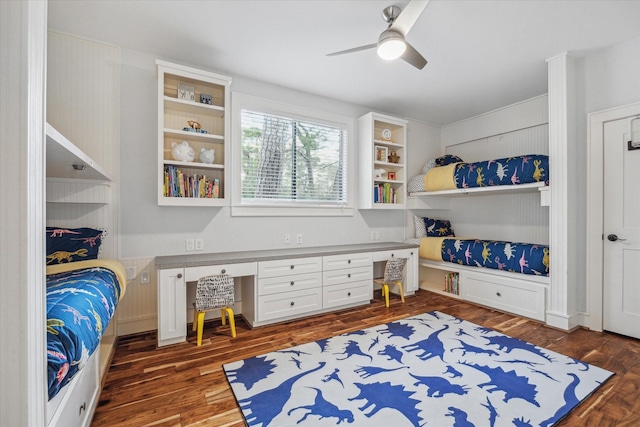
582 102 640 331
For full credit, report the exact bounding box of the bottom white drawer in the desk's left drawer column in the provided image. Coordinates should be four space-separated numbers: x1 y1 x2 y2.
258 288 322 322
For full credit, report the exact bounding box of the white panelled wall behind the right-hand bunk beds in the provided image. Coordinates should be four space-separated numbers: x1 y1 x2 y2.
414 95 549 244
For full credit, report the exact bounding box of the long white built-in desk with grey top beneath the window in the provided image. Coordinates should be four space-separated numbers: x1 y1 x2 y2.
155 242 418 347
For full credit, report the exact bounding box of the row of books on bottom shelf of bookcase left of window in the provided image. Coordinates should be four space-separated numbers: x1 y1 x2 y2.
163 165 220 199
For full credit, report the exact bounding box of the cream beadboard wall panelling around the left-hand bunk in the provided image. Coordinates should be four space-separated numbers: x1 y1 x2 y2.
46 31 126 344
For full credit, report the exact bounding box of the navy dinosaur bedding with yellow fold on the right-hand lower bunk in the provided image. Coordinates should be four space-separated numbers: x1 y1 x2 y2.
419 237 549 276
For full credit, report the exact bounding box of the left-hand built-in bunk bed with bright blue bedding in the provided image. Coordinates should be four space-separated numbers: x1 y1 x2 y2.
45 123 127 426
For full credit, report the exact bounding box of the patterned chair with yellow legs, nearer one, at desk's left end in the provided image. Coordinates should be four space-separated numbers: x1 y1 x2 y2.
193 274 236 346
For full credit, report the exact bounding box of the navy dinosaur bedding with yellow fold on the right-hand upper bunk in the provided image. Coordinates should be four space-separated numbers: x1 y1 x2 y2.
408 154 549 192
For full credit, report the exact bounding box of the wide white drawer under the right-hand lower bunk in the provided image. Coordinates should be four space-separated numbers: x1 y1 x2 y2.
460 273 546 321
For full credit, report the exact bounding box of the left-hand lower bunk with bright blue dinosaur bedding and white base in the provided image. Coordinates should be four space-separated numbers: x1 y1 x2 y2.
46 259 127 426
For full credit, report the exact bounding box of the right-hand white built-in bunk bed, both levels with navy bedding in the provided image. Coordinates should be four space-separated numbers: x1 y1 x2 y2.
407 154 551 320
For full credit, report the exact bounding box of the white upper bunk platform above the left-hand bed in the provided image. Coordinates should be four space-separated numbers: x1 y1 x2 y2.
46 123 111 181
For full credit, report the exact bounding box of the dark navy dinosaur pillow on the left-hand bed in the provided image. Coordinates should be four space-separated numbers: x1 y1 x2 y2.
46 227 105 265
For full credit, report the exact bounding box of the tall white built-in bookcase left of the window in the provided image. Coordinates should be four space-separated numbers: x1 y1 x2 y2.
156 60 231 206
